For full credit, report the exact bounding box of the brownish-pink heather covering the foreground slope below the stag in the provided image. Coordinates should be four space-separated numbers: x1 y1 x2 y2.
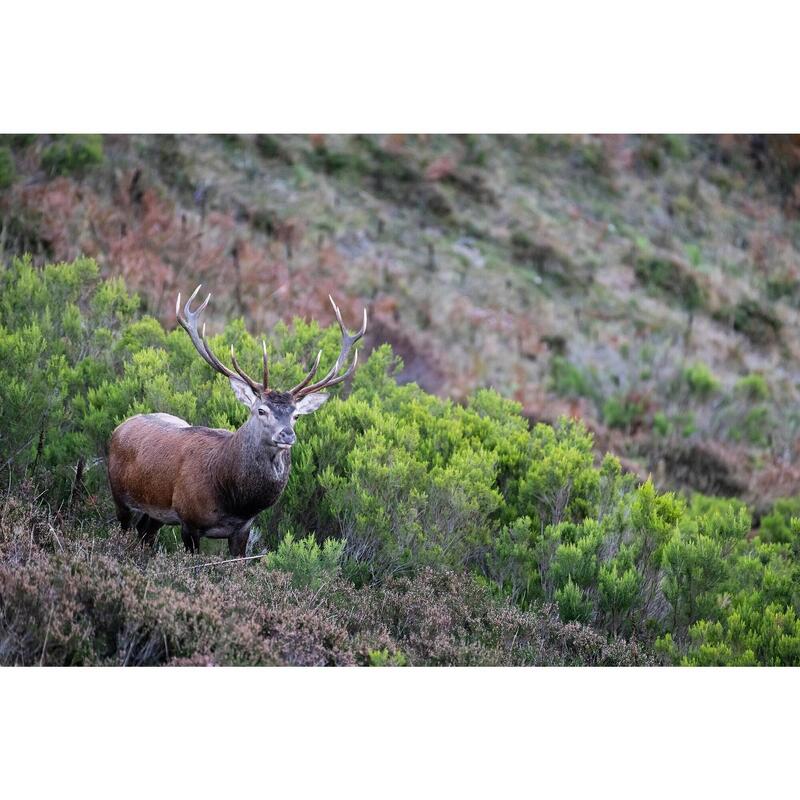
0 497 651 666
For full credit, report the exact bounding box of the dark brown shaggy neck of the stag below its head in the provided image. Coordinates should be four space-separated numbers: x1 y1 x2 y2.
217 417 292 517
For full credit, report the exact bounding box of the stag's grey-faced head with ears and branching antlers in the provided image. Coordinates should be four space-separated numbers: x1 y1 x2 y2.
175 286 367 449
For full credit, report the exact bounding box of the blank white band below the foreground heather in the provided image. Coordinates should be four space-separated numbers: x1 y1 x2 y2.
0 668 800 800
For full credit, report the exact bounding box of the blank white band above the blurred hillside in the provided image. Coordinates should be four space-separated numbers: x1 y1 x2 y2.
6 0 800 133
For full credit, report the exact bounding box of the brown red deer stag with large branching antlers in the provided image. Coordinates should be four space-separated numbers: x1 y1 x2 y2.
108 285 367 557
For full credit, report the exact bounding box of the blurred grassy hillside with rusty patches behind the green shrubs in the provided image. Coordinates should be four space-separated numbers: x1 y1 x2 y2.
0 135 800 515
